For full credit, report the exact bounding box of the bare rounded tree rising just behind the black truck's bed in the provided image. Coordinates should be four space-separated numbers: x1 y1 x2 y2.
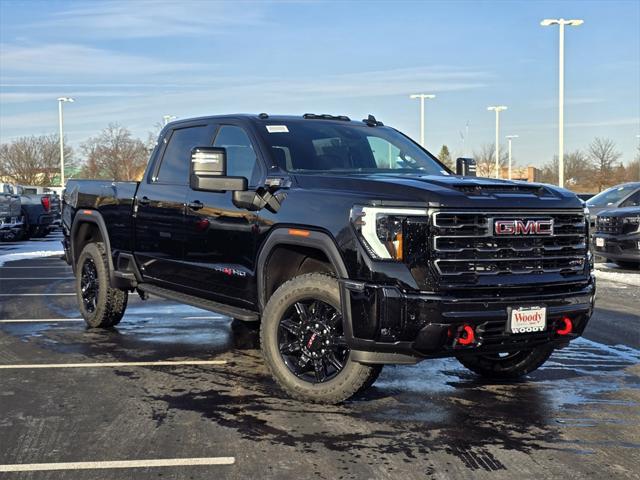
82 123 149 181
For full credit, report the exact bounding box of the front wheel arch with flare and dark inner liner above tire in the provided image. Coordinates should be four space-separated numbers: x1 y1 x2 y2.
256 227 348 312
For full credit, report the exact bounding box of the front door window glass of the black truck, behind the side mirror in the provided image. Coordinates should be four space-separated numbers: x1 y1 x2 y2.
213 125 260 185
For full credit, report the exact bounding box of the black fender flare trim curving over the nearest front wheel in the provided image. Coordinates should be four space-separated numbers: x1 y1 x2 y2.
256 227 349 311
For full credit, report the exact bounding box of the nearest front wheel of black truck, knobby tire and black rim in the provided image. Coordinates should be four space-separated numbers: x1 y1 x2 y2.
260 273 379 404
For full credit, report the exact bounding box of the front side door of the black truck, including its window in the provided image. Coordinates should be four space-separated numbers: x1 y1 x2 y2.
184 124 266 308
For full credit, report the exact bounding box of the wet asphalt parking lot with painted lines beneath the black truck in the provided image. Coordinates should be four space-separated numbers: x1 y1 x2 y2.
0 233 640 479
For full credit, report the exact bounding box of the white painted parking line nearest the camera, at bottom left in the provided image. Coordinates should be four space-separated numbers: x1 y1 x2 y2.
0 457 236 472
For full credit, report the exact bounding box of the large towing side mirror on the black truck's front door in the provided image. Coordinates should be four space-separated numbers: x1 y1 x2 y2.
189 147 249 192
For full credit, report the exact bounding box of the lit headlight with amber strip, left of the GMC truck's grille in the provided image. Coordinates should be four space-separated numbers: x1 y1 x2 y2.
351 206 427 261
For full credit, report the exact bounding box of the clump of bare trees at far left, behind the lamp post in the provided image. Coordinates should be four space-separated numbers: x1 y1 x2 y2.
0 135 74 187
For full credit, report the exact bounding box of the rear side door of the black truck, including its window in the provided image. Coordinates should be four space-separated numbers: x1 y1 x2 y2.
135 123 213 285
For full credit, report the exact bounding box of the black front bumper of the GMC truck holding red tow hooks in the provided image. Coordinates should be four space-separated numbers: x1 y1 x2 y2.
340 277 595 363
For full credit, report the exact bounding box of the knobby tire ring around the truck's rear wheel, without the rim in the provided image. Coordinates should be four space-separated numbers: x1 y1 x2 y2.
76 242 129 328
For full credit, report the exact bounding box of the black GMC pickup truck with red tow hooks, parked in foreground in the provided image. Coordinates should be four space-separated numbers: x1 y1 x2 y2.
63 114 595 403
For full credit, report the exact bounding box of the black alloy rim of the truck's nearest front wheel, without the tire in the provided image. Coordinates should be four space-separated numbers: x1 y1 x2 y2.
278 299 349 383
